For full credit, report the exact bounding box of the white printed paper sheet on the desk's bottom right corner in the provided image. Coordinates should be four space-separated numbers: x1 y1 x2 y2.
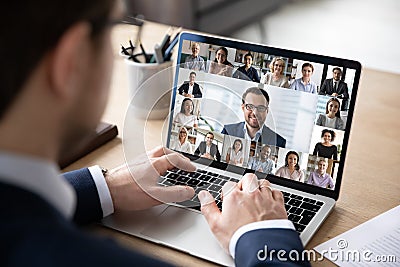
314 206 400 266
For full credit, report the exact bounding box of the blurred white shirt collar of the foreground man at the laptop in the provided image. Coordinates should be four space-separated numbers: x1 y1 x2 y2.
0 151 76 218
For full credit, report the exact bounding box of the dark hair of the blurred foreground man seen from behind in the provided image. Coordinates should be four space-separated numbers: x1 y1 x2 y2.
0 0 115 118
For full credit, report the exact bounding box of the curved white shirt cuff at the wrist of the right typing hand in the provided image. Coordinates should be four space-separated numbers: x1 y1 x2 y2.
229 219 295 258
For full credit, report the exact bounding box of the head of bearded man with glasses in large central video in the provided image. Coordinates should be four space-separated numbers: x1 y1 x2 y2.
242 87 269 130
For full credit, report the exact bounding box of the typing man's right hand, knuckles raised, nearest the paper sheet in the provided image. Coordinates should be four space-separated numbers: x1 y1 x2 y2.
199 174 287 251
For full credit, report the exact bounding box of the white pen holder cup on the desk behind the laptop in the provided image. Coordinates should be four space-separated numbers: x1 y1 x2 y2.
124 56 173 120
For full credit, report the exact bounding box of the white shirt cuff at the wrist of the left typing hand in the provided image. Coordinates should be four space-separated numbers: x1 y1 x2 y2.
88 168 114 217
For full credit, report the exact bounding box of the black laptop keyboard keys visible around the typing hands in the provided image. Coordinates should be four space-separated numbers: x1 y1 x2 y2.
158 168 324 233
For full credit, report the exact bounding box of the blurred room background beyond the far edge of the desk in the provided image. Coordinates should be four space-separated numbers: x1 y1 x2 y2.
125 0 400 74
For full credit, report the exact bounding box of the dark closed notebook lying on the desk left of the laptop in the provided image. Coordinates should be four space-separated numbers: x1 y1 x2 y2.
59 122 118 168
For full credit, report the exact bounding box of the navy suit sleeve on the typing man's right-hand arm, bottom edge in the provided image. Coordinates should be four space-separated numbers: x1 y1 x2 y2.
235 228 310 267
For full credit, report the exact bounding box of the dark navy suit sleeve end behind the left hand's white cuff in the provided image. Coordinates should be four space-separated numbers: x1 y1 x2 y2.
63 168 103 224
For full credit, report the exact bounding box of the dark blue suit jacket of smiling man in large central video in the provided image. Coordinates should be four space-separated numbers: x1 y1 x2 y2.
221 121 286 147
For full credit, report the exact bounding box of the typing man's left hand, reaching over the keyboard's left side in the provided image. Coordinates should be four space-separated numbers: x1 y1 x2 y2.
106 147 196 211
